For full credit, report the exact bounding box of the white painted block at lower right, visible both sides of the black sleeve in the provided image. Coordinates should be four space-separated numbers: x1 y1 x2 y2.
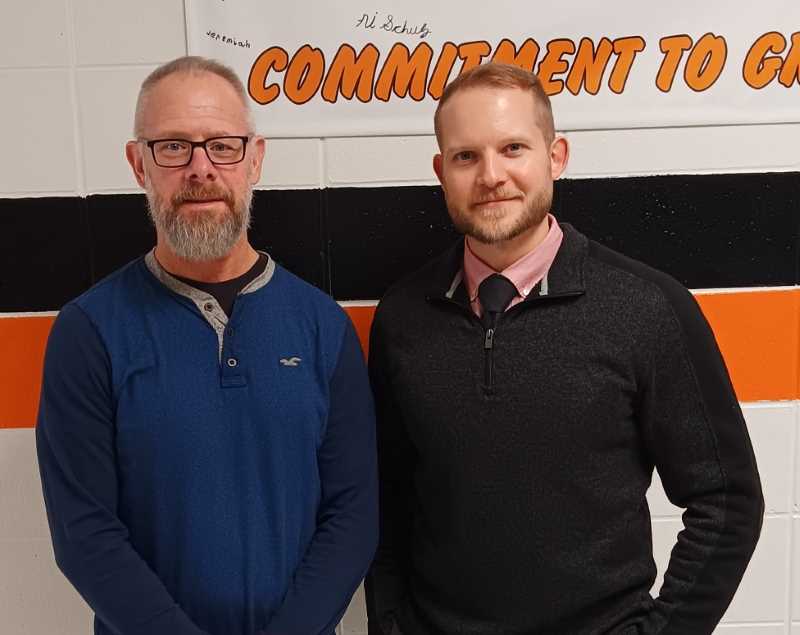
652 516 791 622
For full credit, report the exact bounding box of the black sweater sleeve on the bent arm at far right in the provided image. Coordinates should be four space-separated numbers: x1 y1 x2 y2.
640 285 764 635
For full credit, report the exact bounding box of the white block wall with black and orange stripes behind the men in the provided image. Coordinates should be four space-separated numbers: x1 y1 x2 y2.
0 0 800 635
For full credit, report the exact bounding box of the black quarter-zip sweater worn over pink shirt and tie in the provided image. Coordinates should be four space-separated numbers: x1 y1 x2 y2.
367 225 763 635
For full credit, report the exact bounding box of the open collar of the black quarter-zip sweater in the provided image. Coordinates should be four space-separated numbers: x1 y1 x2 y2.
428 223 589 304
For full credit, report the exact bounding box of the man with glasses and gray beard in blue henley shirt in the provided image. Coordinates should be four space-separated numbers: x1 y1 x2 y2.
37 57 377 635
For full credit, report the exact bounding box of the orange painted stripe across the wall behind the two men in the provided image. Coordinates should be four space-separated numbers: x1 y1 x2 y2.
0 289 800 428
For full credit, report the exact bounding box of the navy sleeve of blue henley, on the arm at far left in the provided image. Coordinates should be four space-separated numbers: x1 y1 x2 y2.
36 304 203 635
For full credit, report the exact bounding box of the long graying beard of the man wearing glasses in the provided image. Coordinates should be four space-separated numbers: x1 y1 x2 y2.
147 187 253 262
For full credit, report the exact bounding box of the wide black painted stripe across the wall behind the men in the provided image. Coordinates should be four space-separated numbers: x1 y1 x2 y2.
0 172 800 312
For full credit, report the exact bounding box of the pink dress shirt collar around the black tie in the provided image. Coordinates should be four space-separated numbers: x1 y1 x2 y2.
464 214 564 317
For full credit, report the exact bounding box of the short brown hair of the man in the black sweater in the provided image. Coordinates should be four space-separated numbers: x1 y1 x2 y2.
433 62 555 148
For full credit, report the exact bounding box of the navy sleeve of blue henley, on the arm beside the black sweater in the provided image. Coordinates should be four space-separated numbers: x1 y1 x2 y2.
266 322 378 635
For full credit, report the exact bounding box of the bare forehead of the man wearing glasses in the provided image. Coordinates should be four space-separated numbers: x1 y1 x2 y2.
140 73 250 136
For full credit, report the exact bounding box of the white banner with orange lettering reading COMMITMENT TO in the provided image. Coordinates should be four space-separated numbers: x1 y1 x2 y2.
186 0 800 137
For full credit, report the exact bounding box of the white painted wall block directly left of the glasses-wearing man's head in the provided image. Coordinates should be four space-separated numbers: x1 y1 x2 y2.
77 68 152 194
